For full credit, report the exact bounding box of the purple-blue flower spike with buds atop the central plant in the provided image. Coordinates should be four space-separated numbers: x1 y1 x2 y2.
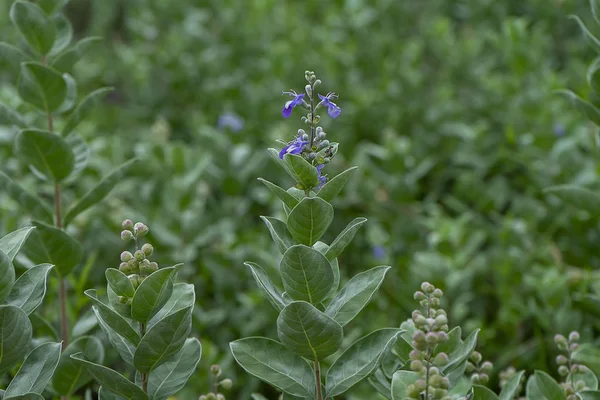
279 71 342 188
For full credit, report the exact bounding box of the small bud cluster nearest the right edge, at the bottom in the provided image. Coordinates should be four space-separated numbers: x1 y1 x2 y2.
554 331 588 400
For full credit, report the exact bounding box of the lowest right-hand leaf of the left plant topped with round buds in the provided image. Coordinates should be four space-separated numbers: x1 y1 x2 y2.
148 338 202 400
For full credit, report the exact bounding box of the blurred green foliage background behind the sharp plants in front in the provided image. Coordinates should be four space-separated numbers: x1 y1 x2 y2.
0 0 600 400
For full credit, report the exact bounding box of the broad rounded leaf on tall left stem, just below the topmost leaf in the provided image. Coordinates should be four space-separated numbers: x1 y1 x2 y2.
18 61 67 113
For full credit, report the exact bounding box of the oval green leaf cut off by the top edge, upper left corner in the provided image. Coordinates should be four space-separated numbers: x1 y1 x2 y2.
10 1 56 54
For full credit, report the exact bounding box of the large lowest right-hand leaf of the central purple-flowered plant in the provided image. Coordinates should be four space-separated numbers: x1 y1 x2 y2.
325 329 400 399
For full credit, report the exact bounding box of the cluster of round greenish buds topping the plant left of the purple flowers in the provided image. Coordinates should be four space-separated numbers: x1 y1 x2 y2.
119 219 158 294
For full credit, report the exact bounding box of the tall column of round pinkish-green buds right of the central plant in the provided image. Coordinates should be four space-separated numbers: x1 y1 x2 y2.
407 282 451 400
